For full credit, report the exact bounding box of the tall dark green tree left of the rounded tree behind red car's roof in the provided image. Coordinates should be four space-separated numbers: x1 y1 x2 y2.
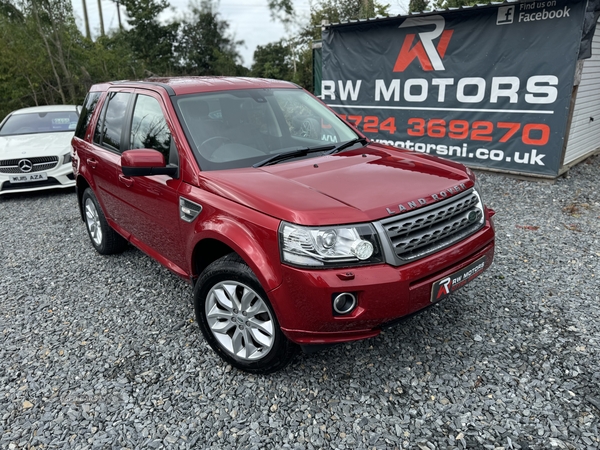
121 0 180 75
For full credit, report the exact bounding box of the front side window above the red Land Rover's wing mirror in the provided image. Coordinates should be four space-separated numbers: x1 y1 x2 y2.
130 95 171 163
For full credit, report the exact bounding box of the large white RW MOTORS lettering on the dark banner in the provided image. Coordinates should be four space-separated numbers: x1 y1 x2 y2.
321 75 558 105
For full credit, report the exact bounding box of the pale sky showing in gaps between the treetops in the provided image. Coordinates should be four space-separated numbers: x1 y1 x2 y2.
71 0 409 67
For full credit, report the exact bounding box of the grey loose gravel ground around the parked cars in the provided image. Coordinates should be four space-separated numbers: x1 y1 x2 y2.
0 156 600 449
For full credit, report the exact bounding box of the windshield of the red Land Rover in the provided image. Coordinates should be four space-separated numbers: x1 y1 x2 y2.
175 89 358 170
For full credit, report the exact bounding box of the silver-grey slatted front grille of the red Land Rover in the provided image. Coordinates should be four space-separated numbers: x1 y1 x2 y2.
379 189 484 264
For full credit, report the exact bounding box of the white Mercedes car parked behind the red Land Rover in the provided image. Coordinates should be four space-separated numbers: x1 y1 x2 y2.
0 105 79 195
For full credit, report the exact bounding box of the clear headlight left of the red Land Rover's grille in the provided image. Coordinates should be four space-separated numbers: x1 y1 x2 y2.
279 222 382 267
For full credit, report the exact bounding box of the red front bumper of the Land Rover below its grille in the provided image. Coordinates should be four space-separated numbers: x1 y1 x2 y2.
268 220 494 345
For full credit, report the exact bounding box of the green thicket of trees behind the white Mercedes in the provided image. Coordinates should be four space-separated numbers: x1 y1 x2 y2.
0 0 143 117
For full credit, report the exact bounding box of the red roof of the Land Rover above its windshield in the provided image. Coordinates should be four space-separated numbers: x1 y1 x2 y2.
90 76 301 95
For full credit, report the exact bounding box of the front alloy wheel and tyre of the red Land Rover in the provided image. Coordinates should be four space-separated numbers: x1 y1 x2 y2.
194 253 297 374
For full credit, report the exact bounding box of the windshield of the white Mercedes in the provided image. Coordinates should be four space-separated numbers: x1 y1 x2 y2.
0 110 79 136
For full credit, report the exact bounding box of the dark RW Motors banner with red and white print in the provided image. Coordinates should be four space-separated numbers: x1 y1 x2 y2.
321 0 586 175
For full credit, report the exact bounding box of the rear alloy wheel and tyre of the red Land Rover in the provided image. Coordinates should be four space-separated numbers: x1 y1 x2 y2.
81 188 127 255
